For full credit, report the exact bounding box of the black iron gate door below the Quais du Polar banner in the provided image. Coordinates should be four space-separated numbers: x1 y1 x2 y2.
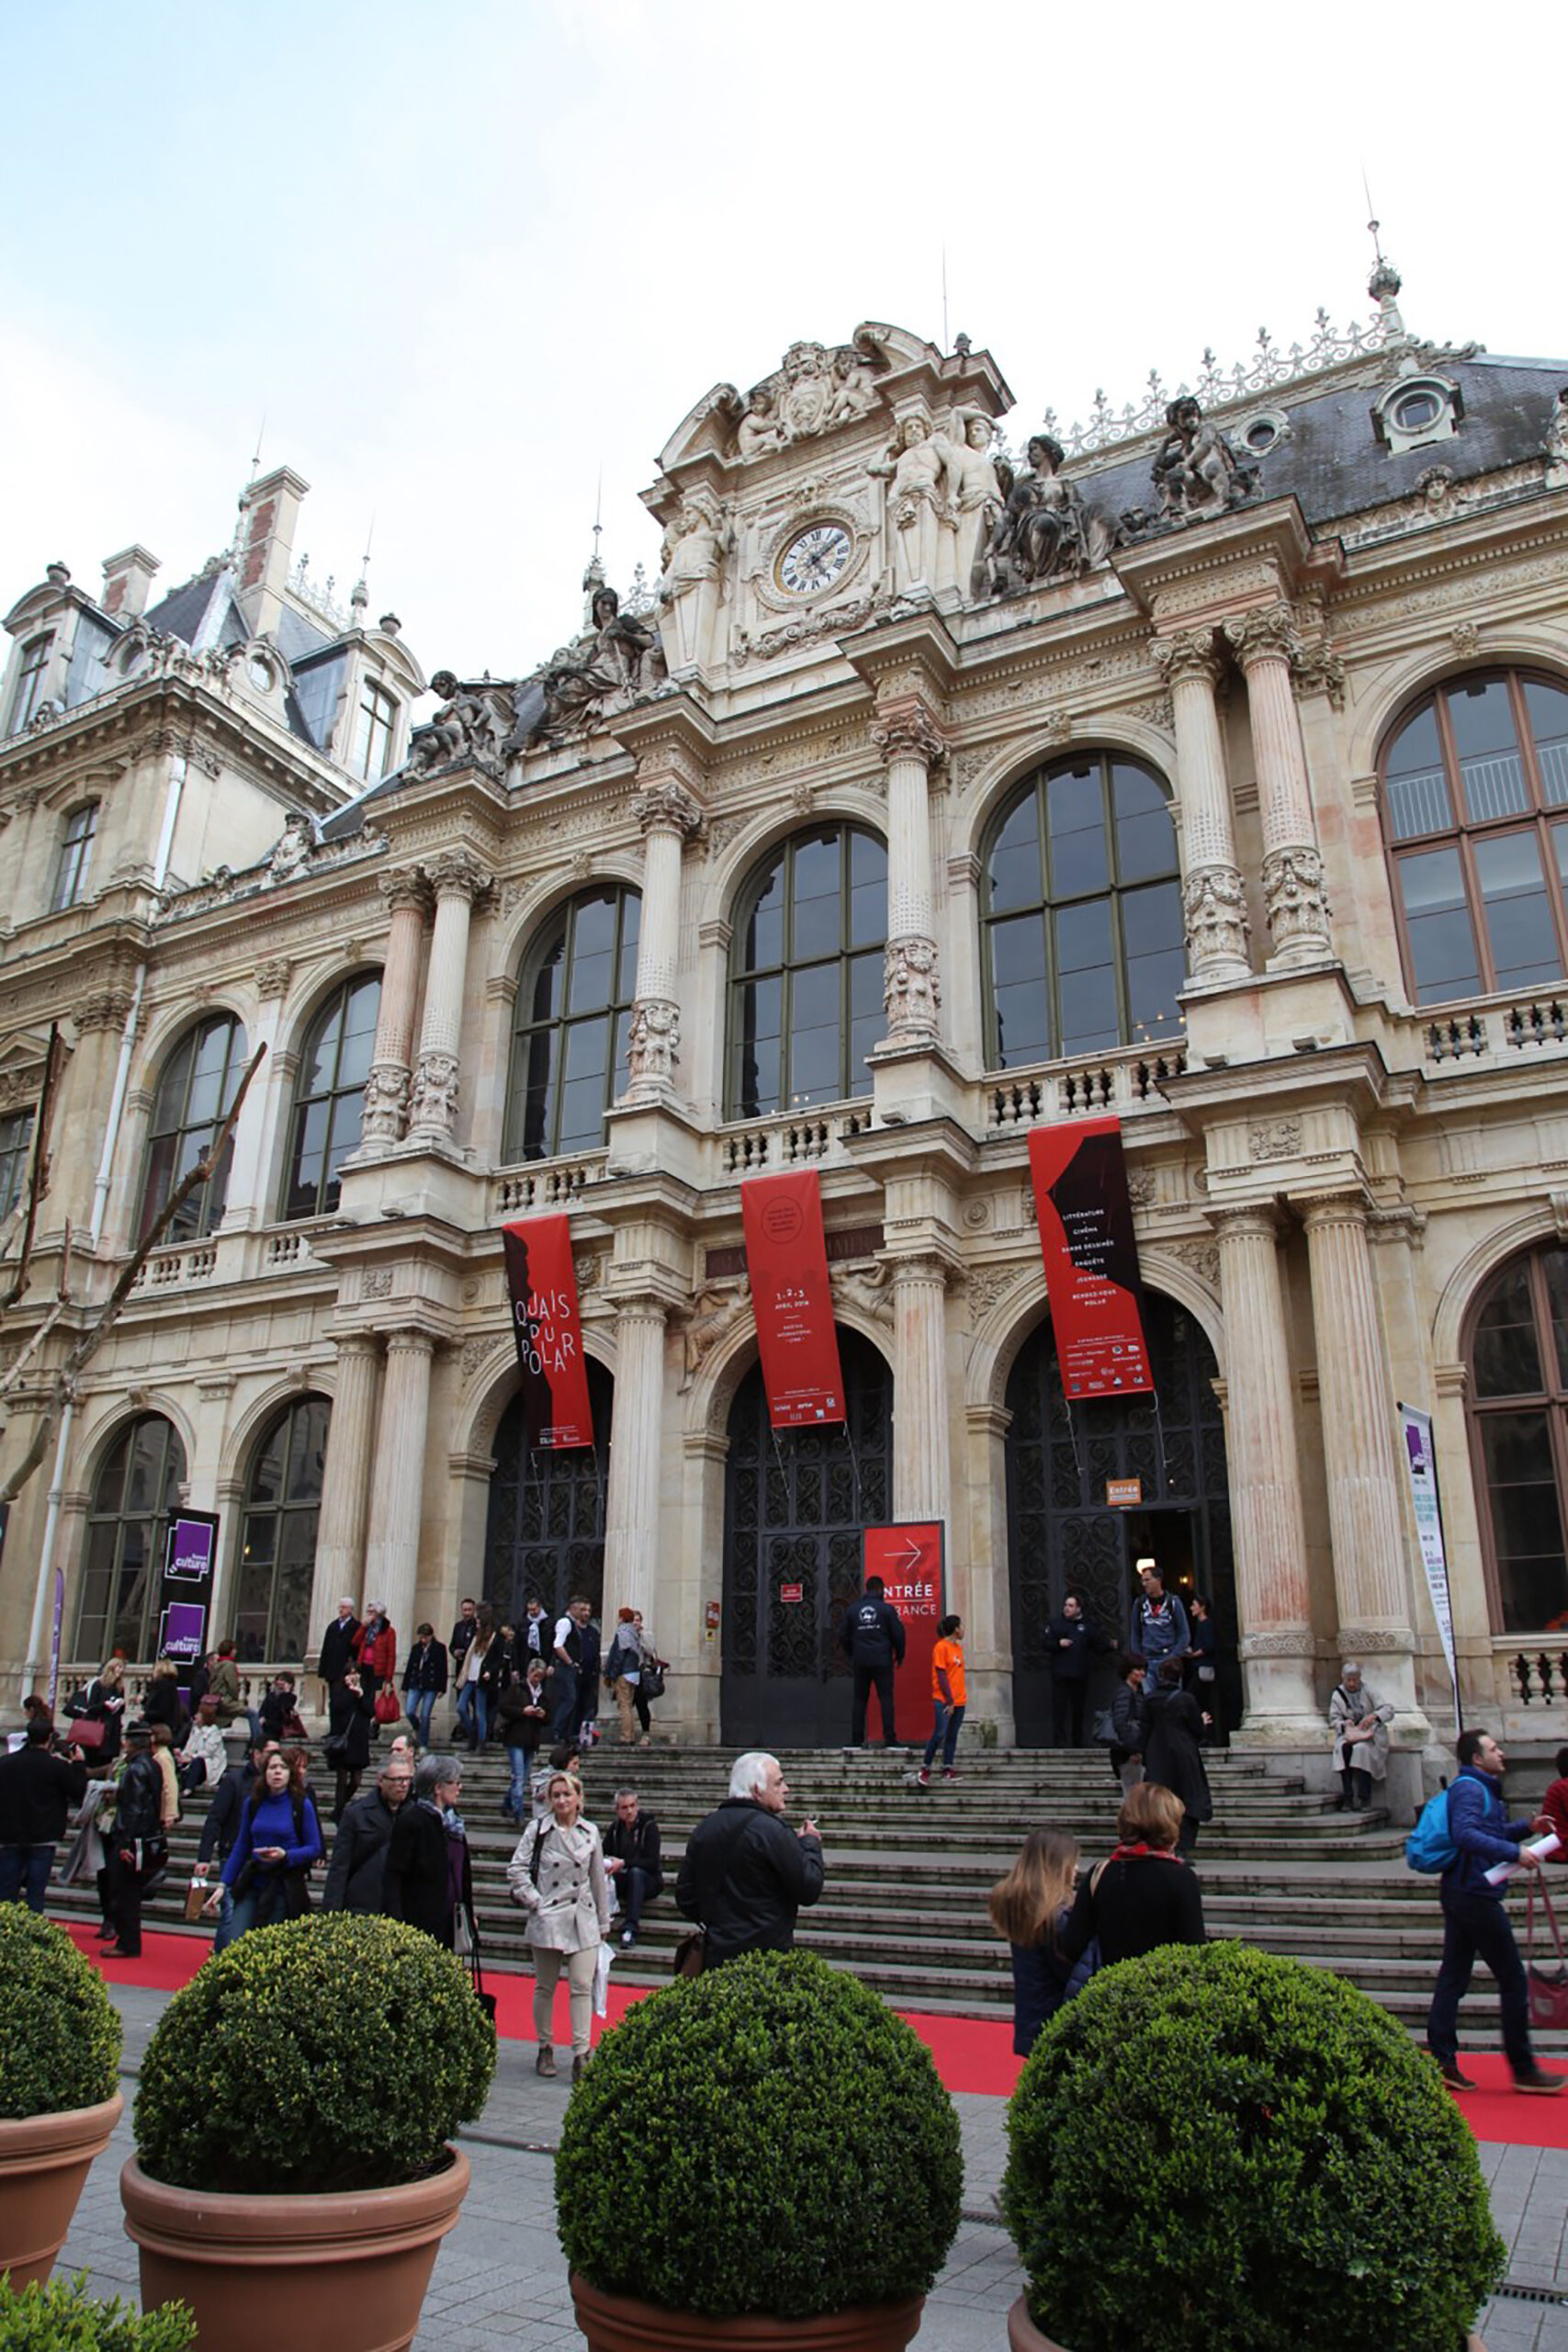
484 1357 611 1633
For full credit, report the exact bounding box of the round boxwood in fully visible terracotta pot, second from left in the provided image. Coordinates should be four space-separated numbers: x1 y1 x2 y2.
120 1912 496 2352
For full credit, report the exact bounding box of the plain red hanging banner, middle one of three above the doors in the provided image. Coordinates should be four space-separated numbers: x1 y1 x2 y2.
740 1169 844 1430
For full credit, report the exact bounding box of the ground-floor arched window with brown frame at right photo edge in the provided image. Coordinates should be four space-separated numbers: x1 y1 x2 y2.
1470 1249 1568 1633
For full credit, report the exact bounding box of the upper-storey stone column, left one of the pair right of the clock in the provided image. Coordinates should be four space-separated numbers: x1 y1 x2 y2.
1155 628 1253 981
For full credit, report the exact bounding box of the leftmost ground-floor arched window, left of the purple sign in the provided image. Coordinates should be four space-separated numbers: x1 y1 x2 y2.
75 1414 186 1660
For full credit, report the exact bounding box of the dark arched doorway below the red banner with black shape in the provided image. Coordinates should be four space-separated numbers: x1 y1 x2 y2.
1006 1291 1241 1747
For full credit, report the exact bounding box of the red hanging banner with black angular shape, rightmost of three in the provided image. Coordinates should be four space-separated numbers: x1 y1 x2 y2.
1030 1120 1155 1397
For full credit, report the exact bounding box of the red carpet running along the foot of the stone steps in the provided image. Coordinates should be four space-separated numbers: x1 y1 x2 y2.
71 1922 1568 2147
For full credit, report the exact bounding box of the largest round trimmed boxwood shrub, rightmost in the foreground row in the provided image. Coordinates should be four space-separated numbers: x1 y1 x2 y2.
1001 1943 1505 2352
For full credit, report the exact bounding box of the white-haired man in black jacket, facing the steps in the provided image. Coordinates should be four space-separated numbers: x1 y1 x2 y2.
674 1747 823 1969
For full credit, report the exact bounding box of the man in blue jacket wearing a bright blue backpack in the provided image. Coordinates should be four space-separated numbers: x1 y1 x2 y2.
1405 1731 1565 2093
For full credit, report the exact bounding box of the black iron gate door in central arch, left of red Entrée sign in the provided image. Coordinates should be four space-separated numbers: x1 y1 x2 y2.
719 1329 894 1747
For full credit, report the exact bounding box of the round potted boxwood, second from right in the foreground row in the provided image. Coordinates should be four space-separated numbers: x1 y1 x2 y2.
555 1952 964 2352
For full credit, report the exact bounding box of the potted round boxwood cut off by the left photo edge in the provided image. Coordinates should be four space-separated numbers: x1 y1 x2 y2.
0 1903 125 2286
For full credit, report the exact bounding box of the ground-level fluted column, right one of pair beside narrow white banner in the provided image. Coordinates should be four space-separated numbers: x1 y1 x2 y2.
1304 1193 1416 1713
